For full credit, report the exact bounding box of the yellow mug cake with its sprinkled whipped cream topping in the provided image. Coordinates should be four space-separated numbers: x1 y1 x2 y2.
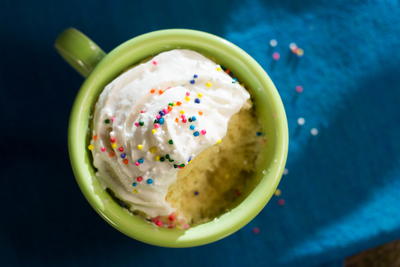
89 49 262 228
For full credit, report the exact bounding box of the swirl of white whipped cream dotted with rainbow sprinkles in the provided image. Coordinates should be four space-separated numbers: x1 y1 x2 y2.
90 49 250 217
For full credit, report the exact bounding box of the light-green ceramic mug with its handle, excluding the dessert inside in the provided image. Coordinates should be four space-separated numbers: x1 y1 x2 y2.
55 28 288 247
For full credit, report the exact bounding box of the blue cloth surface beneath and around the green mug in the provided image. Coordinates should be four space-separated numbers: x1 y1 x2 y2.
0 0 400 266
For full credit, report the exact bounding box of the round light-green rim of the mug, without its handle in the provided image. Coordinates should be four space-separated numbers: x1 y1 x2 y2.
68 29 288 247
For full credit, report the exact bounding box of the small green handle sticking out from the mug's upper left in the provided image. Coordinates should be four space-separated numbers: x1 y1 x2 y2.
54 28 106 78
